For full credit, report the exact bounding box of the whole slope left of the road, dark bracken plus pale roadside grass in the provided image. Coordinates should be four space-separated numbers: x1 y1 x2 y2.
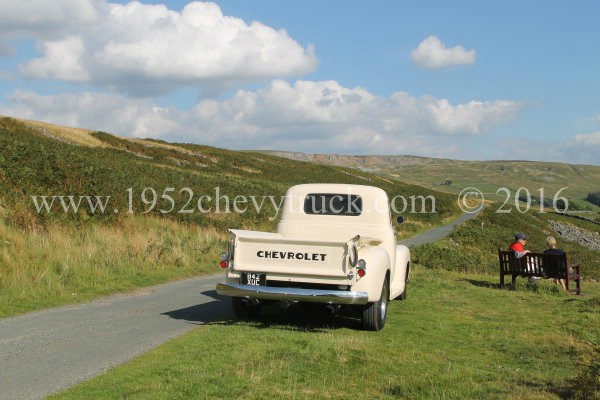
0 118 457 318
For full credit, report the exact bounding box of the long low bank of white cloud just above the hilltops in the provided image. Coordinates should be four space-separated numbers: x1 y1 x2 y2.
0 80 522 157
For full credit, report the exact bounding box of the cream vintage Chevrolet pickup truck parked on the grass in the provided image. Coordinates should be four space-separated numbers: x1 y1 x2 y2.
217 184 410 330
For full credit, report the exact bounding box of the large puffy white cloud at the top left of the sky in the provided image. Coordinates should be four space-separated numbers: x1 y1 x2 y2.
0 0 317 96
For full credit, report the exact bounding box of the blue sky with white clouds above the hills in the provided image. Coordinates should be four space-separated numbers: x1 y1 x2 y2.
0 0 600 165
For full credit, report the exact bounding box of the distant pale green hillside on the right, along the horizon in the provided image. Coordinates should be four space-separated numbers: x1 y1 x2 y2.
266 151 600 216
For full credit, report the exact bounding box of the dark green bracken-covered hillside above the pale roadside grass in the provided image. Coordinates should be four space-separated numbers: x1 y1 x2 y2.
0 118 458 229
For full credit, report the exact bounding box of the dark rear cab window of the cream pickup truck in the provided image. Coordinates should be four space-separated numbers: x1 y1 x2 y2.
304 193 362 216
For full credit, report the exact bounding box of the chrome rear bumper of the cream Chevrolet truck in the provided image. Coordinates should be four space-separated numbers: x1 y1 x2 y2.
217 283 369 304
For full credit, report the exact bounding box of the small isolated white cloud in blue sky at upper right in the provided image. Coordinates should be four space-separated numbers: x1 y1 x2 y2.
410 36 477 69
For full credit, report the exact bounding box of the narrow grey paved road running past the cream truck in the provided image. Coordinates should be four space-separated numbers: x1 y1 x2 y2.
0 214 473 400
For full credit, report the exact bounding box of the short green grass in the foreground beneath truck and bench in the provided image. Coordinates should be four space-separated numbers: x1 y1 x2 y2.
50 266 600 399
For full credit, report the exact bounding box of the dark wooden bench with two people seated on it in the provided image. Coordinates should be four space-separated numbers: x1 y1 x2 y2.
498 249 581 294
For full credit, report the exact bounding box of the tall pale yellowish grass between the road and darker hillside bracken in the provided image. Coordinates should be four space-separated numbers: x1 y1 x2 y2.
0 217 227 318
